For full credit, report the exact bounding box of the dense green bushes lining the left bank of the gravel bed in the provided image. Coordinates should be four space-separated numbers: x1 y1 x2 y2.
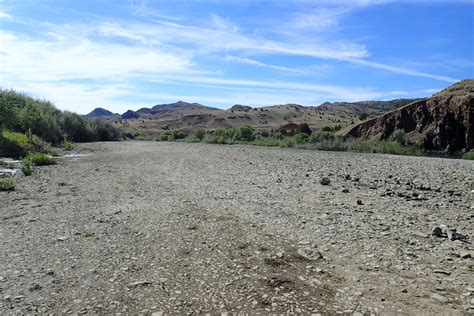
0 89 120 157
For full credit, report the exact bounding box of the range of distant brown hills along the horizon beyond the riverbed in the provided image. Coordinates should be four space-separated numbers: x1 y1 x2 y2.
83 100 412 134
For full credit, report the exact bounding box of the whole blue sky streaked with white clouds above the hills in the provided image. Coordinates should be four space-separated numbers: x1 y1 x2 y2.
0 0 474 113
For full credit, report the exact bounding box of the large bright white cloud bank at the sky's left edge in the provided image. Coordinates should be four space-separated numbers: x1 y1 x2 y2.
0 31 191 81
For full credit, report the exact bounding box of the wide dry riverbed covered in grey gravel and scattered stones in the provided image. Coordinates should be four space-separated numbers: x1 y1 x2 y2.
0 142 474 314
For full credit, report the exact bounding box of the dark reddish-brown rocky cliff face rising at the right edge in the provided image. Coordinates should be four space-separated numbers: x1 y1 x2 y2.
348 80 474 153
